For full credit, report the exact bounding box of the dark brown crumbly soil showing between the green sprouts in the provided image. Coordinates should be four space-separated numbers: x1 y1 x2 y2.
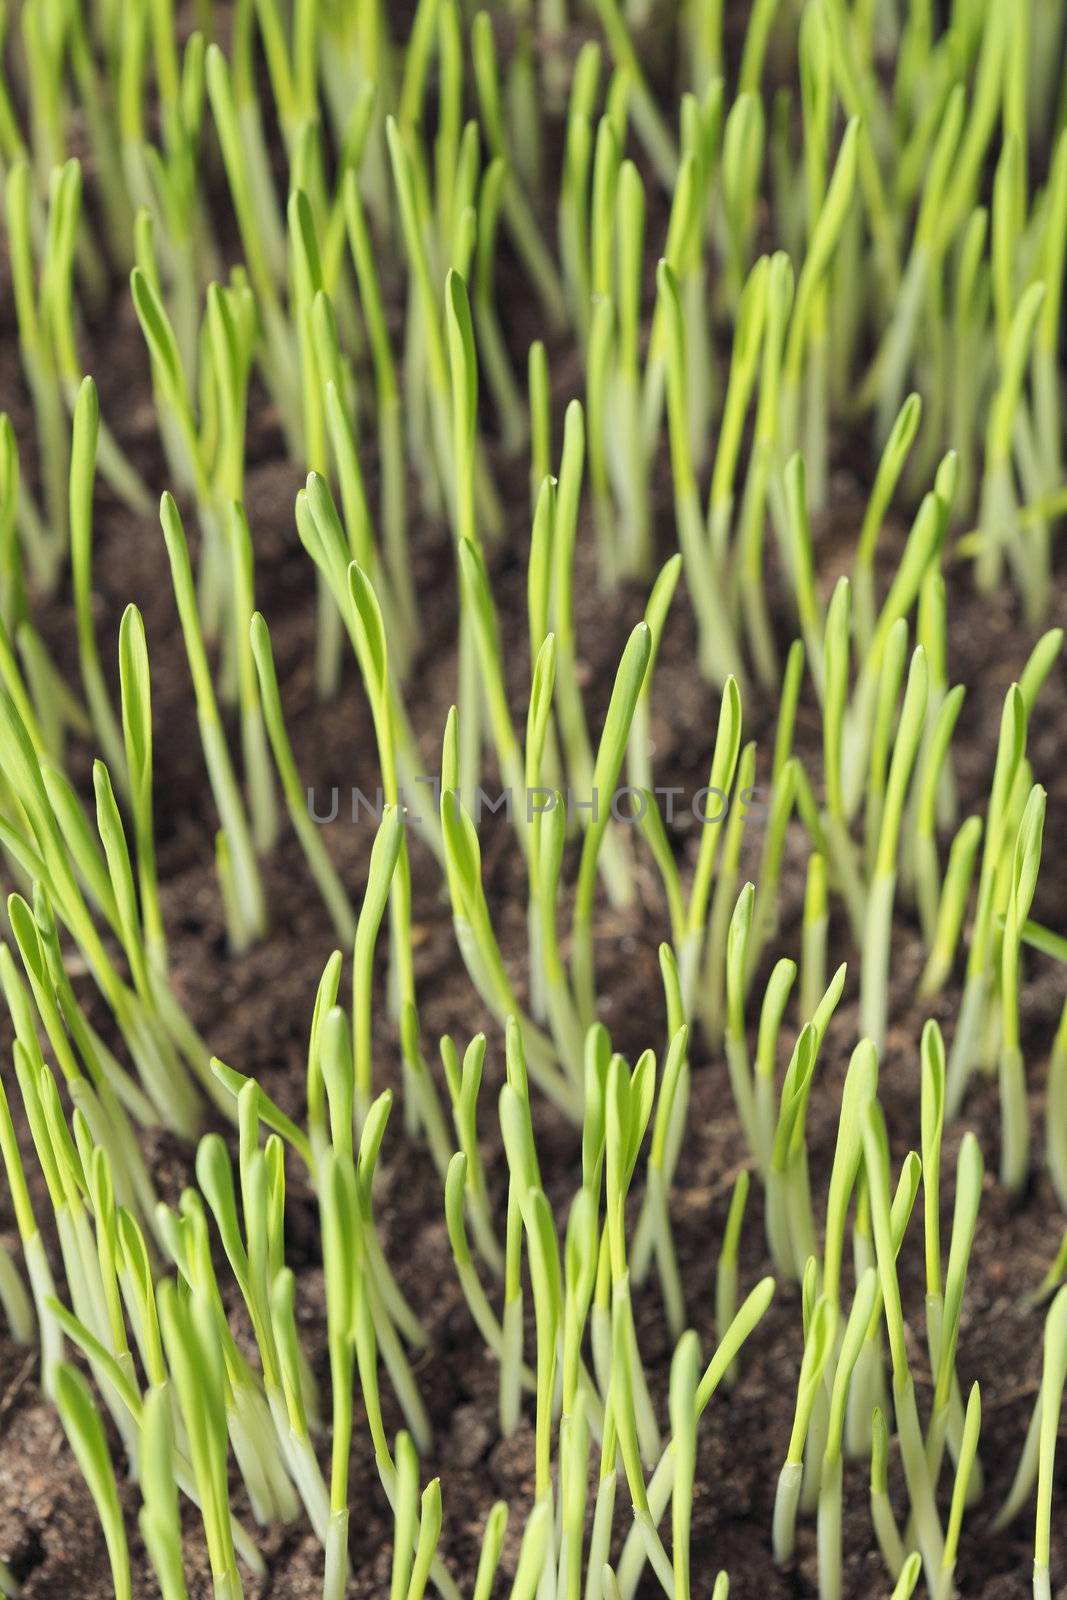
0 8 1067 1600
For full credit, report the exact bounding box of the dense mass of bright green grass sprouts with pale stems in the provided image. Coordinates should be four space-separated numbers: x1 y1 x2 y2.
0 0 1067 1600
